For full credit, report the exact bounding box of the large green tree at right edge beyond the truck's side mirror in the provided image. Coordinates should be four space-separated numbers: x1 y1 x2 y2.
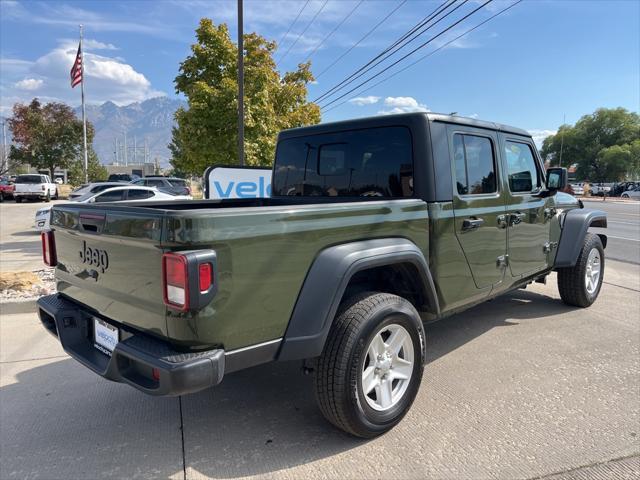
541 108 640 182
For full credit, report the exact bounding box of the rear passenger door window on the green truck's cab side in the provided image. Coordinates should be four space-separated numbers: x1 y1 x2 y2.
453 133 497 195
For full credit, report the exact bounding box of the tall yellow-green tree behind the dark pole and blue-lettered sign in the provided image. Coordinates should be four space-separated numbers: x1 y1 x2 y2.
170 18 320 175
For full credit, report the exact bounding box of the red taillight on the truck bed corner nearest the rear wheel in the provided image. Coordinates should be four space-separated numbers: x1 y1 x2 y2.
162 250 217 312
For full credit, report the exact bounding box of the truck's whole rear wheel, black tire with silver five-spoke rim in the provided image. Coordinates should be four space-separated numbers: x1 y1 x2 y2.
315 293 424 438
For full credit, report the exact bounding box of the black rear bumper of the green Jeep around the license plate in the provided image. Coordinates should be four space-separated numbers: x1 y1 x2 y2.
38 294 225 396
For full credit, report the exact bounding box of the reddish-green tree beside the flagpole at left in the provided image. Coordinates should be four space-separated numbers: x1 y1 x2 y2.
8 98 93 175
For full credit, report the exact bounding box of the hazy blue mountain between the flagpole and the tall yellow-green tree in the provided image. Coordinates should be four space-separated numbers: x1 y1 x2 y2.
76 97 186 167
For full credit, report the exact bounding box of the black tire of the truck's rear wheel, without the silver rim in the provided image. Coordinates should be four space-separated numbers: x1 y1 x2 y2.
315 292 425 438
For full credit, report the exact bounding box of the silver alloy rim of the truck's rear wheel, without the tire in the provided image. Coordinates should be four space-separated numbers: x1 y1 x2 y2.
361 323 414 411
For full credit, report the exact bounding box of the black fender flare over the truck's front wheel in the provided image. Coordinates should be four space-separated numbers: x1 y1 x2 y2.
553 208 607 268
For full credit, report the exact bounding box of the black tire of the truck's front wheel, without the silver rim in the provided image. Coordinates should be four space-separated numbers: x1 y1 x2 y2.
558 233 605 308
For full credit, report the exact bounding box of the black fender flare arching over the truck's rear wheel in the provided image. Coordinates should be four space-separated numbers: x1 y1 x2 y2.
278 238 440 360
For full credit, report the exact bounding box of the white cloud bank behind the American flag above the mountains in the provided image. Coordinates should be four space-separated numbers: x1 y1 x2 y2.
0 39 164 111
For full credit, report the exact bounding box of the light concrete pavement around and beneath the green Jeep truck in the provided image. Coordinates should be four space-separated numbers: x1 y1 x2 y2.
0 201 640 479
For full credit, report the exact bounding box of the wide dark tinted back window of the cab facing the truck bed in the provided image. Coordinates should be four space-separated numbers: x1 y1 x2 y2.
273 127 413 197
